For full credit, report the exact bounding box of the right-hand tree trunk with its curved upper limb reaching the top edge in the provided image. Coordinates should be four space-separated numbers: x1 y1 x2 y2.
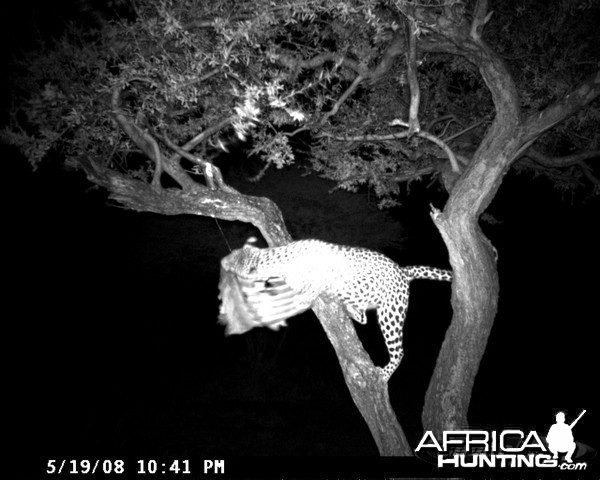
422 0 522 434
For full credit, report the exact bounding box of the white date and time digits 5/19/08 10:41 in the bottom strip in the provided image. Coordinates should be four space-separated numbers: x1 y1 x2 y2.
45 459 195 476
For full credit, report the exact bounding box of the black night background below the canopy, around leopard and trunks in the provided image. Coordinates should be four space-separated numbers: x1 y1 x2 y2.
2 0 600 478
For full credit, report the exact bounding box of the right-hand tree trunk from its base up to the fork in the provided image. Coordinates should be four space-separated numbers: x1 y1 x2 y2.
422 124 521 434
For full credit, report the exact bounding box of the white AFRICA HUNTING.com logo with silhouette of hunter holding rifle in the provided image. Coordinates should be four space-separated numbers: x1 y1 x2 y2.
415 410 595 470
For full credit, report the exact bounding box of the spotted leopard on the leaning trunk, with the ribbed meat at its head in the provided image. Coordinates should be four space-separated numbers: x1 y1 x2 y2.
219 237 452 382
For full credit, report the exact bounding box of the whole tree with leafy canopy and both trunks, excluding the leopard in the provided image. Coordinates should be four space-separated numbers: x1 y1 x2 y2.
3 0 600 455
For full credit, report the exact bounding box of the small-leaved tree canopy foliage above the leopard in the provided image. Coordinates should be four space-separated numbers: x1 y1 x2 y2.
3 0 600 205
